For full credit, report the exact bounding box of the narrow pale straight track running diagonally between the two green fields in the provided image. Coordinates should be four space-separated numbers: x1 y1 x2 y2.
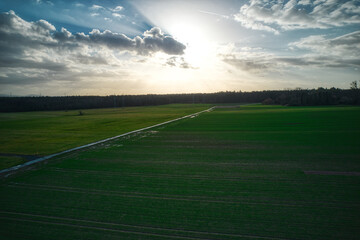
0 106 216 178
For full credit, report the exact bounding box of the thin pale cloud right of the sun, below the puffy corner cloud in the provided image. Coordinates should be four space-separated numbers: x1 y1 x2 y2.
219 31 360 74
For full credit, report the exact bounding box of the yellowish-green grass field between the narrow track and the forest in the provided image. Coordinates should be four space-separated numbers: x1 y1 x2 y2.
0 104 210 169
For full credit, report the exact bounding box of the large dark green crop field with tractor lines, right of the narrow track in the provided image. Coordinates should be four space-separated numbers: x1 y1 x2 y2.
0 105 360 240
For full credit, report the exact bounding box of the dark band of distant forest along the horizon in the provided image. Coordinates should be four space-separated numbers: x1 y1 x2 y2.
0 87 360 112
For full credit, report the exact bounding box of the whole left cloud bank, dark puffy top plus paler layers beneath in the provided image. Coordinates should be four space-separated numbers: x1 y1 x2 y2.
0 11 186 89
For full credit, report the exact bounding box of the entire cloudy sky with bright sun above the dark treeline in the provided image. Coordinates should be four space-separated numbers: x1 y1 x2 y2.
0 0 360 96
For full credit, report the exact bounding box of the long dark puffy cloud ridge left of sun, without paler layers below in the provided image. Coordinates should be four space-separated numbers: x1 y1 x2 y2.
0 11 186 59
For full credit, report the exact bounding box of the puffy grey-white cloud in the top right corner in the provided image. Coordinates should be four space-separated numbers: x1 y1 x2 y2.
234 0 360 34
